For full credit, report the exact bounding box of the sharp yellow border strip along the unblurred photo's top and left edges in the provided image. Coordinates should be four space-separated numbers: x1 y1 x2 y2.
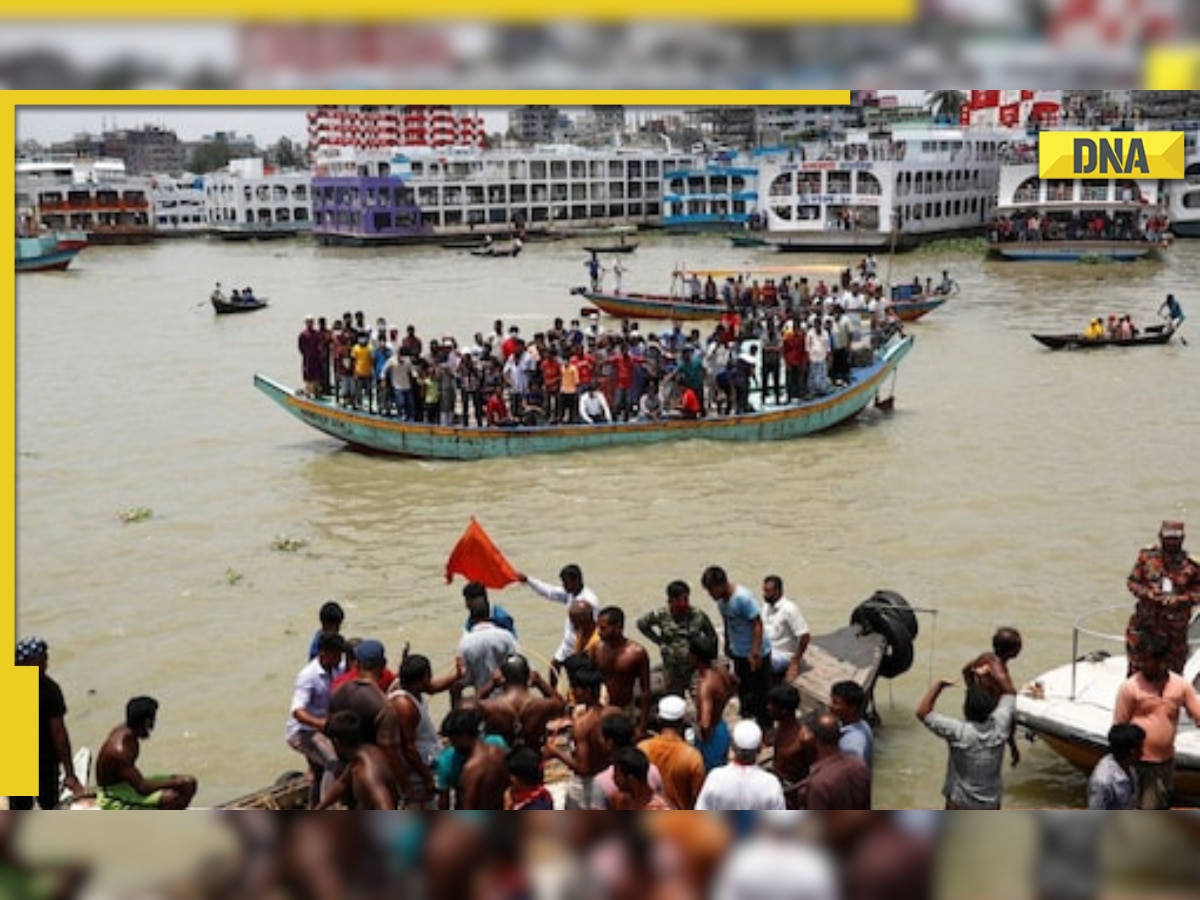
7 90 854 797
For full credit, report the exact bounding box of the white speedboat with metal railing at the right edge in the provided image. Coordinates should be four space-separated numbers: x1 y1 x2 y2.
1016 605 1200 798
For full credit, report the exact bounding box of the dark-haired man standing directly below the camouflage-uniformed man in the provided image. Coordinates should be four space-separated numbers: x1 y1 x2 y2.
1112 636 1200 809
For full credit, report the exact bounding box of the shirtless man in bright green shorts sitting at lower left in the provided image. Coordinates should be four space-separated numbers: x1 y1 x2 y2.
96 697 197 810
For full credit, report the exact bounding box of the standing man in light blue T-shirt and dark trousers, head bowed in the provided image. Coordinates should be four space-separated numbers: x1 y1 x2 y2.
701 565 770 730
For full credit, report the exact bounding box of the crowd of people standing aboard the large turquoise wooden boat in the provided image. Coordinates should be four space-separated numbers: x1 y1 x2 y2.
296 257 926 427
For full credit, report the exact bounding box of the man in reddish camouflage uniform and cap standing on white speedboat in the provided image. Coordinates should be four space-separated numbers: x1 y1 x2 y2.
1126 521 1200 674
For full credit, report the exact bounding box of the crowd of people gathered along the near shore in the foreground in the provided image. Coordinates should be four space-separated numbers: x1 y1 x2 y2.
11 521 1200 811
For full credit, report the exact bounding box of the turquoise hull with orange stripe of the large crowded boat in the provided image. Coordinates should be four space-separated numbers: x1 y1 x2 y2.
254 336 913 461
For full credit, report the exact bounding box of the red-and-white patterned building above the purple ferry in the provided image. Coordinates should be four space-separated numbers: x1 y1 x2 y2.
308 106 487 152
